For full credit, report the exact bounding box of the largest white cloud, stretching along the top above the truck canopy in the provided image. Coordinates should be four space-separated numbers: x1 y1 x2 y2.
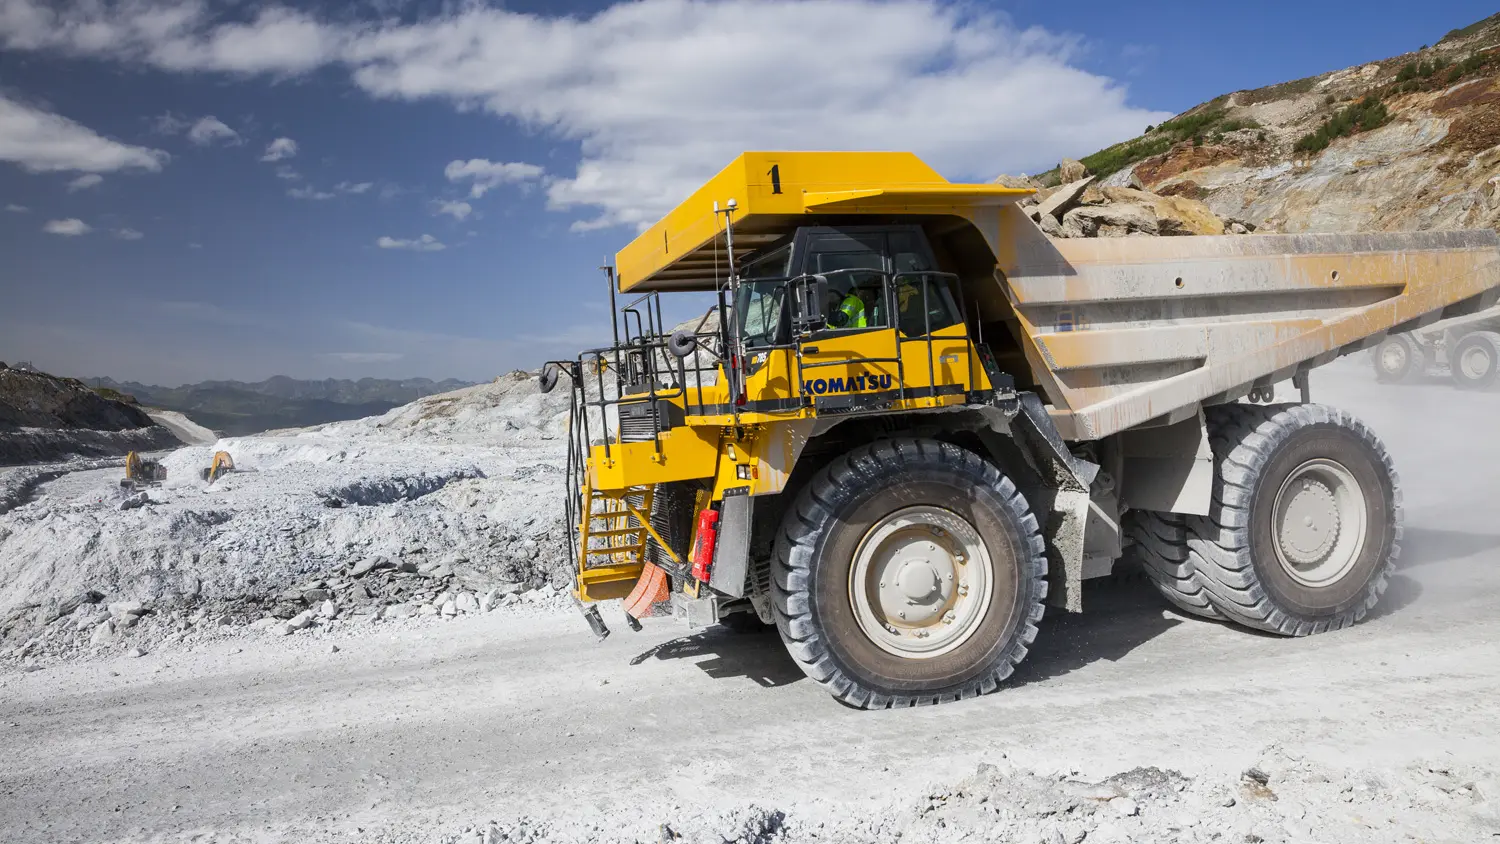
0 0 1169 228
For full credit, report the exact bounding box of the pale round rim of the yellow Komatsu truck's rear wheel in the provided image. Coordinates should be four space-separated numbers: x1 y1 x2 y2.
1272 459 1368 588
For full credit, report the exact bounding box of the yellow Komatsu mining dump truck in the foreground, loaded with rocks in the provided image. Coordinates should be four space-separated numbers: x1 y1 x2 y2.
542 153 1500 709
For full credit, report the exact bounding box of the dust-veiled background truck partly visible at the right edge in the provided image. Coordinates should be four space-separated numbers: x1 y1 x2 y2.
1371 307 1500 390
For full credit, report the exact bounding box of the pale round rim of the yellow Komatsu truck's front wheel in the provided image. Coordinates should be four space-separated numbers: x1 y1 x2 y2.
849 505 993 660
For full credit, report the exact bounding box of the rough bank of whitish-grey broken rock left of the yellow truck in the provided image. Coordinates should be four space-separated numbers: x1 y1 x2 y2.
0 373 579 666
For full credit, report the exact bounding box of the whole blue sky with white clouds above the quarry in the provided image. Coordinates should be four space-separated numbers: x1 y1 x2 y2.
0 0 1496 385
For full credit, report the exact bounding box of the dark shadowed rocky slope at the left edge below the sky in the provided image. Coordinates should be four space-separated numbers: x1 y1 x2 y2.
0 364 179 466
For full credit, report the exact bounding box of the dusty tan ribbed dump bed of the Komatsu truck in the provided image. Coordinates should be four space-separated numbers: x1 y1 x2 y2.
998 210 1500 439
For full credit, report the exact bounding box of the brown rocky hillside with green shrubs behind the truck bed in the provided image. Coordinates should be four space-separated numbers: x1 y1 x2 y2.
1002 15 1500 234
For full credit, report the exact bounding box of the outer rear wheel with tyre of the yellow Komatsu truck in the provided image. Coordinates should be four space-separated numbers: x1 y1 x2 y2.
1187 405 1401 636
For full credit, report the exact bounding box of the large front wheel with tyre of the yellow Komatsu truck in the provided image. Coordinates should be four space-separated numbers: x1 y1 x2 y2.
771 439 1047 709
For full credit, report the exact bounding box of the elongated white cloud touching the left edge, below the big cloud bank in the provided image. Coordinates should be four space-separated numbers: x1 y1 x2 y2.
0 93 168 172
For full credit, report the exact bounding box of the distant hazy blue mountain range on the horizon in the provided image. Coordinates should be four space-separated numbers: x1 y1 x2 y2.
84 375 473 436
